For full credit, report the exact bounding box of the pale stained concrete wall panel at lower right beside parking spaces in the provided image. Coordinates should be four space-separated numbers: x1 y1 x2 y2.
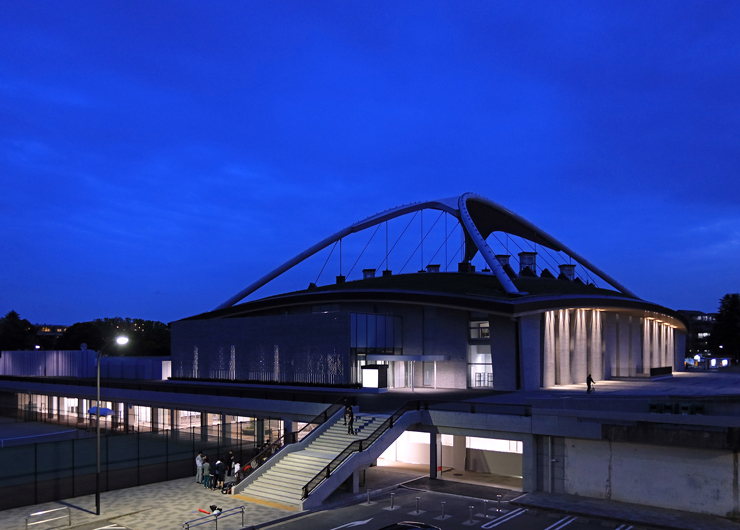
564 438 740 516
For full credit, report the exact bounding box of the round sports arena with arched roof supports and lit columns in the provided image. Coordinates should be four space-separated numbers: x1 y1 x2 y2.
172 194 686 391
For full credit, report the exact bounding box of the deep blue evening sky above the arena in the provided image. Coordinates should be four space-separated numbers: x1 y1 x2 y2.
0 1 740 324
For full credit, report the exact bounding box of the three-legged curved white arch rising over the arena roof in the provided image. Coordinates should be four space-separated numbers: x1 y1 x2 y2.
216 193 637 309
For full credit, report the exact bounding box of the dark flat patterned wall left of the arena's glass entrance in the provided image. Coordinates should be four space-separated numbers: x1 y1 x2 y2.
172 312 351 385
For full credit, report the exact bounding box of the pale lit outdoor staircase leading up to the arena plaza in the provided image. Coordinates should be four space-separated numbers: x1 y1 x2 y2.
239 414 388 508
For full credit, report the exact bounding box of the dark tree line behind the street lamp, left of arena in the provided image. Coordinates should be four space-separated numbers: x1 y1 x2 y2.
0 311 170 356
